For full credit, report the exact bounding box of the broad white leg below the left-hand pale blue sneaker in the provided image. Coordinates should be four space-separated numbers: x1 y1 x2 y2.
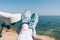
18 23 33 40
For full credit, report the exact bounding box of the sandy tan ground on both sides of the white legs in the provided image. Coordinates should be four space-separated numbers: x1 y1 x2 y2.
0 29 55 40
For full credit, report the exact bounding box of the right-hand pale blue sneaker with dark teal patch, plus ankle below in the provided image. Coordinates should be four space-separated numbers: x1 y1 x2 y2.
29 13 38 39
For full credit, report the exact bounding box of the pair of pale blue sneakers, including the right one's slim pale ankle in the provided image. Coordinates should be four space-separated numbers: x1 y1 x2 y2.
22 11 38 37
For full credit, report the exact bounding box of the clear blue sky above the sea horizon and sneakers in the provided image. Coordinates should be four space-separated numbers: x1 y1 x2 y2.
0 0 60 15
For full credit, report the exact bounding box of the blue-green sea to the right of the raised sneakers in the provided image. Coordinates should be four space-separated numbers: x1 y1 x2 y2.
36 16 60 38
